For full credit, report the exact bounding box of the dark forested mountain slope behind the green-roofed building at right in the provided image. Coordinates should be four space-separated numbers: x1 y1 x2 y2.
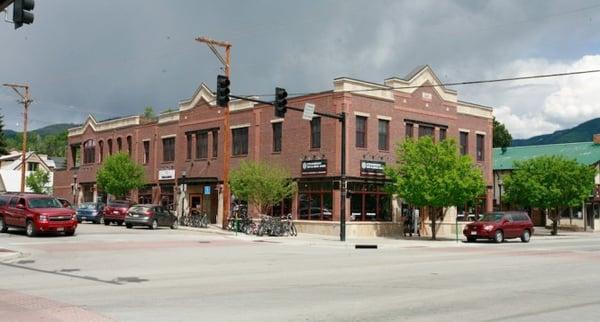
512 118 600 146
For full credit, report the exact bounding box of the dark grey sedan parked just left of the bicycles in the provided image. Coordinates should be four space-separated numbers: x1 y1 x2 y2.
125 204 179 229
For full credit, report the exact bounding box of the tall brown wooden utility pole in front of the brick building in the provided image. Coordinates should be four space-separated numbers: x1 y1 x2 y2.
196 37 231 229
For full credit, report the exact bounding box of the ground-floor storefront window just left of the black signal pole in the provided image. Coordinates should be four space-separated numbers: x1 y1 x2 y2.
298 182 333 220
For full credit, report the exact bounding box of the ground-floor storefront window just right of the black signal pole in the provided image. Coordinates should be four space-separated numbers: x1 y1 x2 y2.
349 182 392 221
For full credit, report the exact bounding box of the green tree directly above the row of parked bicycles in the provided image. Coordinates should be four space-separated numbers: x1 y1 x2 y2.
229 161 296 214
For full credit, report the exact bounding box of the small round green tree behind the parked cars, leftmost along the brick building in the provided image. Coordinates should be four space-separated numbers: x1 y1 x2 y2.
96 152 145 198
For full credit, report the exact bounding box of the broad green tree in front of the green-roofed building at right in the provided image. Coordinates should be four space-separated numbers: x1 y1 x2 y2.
504 156 596 235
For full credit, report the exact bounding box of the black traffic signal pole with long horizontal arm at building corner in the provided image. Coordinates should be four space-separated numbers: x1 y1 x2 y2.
229 94 348 241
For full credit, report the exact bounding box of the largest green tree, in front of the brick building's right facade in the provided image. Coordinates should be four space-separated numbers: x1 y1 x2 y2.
385 136 485 240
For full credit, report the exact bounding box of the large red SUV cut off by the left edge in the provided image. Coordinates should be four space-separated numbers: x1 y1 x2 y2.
0 193 77 237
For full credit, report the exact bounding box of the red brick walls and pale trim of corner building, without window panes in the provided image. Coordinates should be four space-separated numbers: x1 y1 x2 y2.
55 67 492 236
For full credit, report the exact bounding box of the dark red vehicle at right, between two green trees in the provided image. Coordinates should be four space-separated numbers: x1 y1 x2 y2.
463 212 534 243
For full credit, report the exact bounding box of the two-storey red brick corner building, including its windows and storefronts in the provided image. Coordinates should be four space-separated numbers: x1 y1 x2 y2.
54 66 492 236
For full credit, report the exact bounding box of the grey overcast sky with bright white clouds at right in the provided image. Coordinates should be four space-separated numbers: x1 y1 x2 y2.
0 0 600 138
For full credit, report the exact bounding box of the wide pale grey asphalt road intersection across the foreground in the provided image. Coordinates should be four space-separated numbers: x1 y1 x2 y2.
0 224 600 321
